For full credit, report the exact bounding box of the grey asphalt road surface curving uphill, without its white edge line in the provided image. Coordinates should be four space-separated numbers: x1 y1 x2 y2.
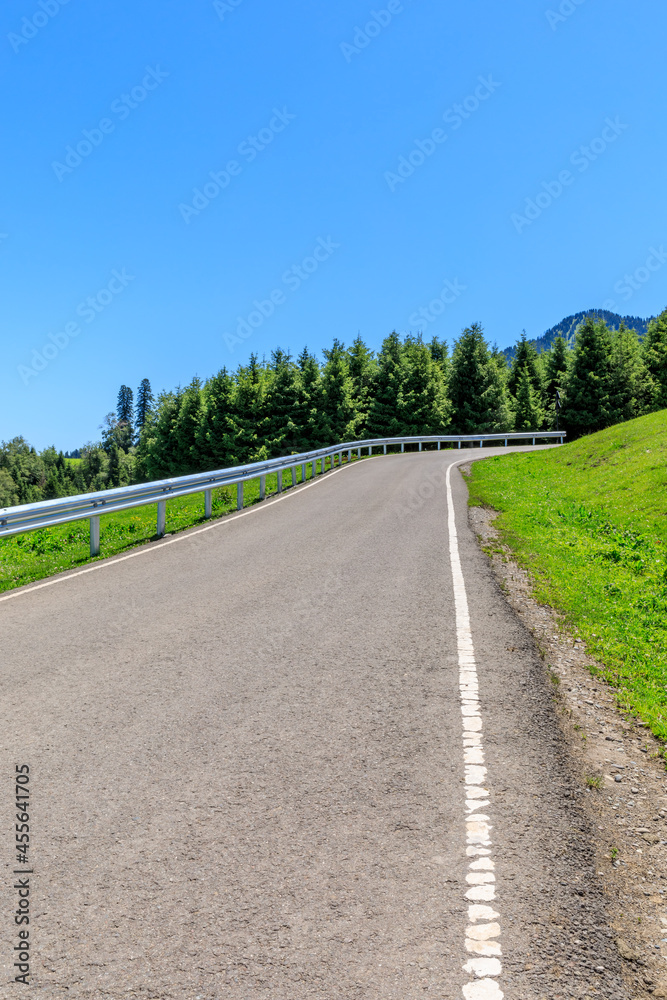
0 449 629 1000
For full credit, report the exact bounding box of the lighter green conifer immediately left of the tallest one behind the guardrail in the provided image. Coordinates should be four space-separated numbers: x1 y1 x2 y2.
398 337 451 436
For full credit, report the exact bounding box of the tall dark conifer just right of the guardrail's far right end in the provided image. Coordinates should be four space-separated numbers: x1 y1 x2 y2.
562 316 612 437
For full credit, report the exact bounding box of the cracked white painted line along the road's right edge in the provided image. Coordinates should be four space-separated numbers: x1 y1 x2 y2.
446 465 505 1000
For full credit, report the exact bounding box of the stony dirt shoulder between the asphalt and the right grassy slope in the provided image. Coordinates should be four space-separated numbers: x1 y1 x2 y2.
469 496 667 998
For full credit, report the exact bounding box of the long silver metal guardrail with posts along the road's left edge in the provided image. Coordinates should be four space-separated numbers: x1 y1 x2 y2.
0 431 567 556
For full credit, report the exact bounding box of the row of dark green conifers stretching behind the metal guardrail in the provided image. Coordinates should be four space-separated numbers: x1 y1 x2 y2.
0 310 667 506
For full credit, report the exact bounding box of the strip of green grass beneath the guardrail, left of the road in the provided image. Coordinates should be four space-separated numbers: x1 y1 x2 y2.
0 456 342 593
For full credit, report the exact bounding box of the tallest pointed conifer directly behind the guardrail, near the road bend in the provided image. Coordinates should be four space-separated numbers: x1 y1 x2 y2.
449 323 513 434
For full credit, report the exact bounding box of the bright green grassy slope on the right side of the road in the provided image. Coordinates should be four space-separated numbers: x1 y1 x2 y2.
469 410 667 740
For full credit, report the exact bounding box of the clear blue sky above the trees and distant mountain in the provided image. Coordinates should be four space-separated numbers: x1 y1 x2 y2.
0 0 667 450
